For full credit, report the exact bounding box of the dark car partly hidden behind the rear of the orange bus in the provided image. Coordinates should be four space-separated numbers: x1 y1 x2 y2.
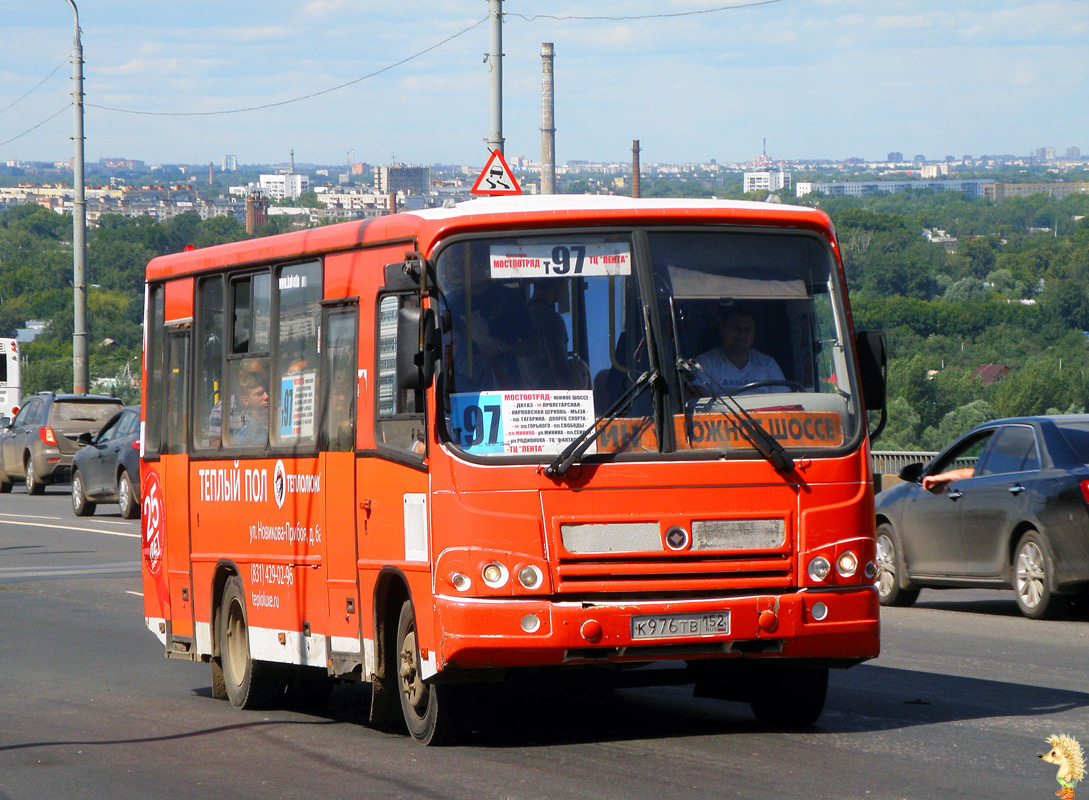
72 406 139 519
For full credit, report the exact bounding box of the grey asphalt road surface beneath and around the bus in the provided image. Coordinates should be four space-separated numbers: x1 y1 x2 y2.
0 487 1089 800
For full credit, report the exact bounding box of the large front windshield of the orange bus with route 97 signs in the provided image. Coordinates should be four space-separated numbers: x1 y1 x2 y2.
436 227 861 461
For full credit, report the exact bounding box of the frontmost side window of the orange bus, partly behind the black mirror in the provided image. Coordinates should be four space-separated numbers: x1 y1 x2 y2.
375 294 427 456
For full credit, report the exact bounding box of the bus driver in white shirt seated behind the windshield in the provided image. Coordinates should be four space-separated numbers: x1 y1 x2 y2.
694 305 785 394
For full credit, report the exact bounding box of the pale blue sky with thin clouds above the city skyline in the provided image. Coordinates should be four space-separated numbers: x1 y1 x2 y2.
0 0 1089 167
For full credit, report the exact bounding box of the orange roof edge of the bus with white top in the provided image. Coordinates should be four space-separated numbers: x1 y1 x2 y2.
147 195 832 281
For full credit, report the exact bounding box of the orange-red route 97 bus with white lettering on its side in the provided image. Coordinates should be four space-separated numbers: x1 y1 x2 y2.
140 196 884 743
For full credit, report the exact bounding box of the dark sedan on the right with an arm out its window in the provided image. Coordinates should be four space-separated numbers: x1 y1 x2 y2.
876 416 1089 618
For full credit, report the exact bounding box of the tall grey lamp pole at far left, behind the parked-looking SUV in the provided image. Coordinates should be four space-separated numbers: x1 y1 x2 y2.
68 0 87 394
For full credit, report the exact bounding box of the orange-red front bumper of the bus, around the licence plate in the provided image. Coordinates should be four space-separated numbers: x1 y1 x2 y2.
436 586 880 669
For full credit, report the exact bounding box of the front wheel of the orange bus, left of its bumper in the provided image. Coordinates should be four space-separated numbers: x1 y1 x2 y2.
393 600 466 746
